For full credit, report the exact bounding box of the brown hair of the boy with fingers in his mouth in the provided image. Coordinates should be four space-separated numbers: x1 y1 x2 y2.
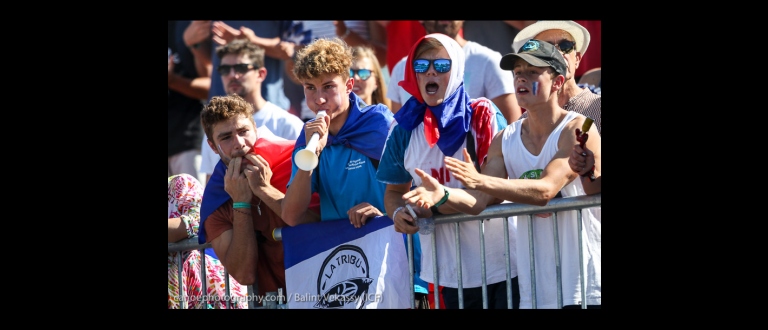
200 94 256 144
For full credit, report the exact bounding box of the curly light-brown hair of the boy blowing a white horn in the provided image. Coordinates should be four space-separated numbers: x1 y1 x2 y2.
293 38 352 81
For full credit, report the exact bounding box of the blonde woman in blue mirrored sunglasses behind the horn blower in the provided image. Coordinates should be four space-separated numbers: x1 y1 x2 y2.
349 46 391 108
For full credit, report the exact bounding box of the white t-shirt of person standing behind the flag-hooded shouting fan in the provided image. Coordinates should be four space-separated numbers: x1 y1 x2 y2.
387 41 515 106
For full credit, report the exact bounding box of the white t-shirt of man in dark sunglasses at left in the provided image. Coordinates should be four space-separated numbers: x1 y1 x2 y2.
200 101 304 174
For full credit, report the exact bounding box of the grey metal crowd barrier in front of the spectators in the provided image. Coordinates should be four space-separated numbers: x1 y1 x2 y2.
168 194 602 309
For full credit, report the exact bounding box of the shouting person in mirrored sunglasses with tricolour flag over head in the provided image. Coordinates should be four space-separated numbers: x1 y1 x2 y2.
376 33 520 309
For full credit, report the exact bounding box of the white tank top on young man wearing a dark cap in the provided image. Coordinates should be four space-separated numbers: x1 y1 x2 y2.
501 111 601 308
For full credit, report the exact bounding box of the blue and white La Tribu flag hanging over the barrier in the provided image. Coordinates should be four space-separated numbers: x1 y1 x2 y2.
282 216 412 309
